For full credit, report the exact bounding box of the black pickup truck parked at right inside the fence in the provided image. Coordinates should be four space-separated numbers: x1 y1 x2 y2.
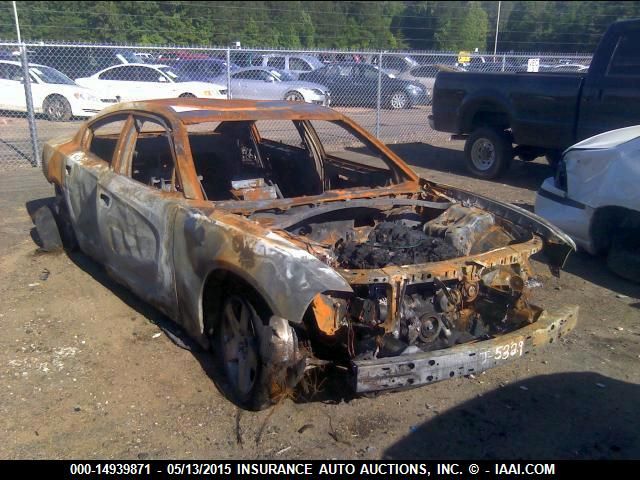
429 20 640 178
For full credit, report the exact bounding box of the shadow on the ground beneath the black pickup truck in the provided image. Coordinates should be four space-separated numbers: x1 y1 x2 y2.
388 143 553 190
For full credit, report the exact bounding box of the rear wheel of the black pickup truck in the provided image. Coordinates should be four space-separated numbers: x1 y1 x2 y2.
464 128 513 178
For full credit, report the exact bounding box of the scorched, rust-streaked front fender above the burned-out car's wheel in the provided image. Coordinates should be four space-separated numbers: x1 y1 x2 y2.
173 209 351 344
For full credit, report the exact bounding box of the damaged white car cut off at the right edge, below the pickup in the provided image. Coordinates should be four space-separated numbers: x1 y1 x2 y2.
535 125 640 281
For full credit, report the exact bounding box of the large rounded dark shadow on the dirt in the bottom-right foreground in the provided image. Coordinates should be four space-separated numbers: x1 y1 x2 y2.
384 373 640 460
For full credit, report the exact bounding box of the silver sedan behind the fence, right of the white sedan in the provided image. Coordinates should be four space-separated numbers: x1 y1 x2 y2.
215 67 330 106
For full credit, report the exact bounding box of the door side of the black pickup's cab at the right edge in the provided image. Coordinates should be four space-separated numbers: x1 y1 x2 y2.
576 30 640 140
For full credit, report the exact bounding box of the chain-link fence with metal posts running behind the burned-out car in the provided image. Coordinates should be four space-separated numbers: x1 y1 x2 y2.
0 42 591 170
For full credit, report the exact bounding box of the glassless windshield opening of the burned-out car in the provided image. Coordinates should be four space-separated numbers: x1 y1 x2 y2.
188 120 406 201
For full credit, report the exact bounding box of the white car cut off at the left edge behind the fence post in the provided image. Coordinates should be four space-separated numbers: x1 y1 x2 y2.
0 60 117 121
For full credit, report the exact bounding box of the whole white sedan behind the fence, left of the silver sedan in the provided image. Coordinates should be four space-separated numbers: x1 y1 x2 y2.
76 63 227 102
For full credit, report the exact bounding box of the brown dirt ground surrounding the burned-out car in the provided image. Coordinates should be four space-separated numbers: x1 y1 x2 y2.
0 142 640 459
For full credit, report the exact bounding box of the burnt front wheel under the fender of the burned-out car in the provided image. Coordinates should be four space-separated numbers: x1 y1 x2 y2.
214 291 272 410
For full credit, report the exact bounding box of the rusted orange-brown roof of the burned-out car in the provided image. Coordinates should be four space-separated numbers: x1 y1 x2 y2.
94 98 344 125
